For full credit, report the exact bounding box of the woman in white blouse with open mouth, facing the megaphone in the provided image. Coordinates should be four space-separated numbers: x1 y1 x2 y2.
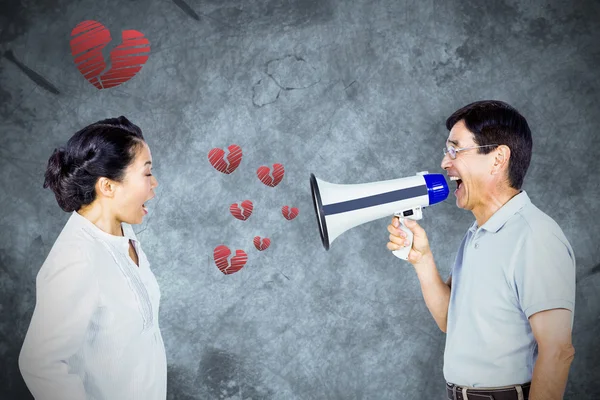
19 117 167 400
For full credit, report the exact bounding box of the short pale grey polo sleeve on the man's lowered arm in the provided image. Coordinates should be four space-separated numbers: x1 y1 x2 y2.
514 233 576 318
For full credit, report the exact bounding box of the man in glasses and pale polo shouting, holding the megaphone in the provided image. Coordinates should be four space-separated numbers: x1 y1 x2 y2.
387 101 575 400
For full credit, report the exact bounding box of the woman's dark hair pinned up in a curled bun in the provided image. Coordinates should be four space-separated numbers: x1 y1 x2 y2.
44 116 144 212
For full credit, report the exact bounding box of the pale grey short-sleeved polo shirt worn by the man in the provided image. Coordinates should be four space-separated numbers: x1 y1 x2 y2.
444 191 575 387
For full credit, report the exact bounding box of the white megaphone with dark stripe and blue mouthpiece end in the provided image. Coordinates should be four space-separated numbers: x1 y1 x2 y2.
310 171 450 260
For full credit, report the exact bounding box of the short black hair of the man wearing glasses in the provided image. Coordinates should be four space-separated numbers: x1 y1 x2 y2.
446 100 532 189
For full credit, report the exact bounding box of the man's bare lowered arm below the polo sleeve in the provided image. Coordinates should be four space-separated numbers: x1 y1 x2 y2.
529 308 575 400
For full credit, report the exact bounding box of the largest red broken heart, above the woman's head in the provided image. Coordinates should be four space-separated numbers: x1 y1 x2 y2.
70 20 150 89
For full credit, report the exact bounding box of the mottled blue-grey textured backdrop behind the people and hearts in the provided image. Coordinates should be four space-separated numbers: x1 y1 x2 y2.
0 0 600 400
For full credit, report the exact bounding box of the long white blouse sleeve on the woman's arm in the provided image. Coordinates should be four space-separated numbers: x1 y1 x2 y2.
19 250 99 400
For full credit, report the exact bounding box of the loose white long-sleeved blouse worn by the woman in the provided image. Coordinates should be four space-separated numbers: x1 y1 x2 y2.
19 211 167 400
